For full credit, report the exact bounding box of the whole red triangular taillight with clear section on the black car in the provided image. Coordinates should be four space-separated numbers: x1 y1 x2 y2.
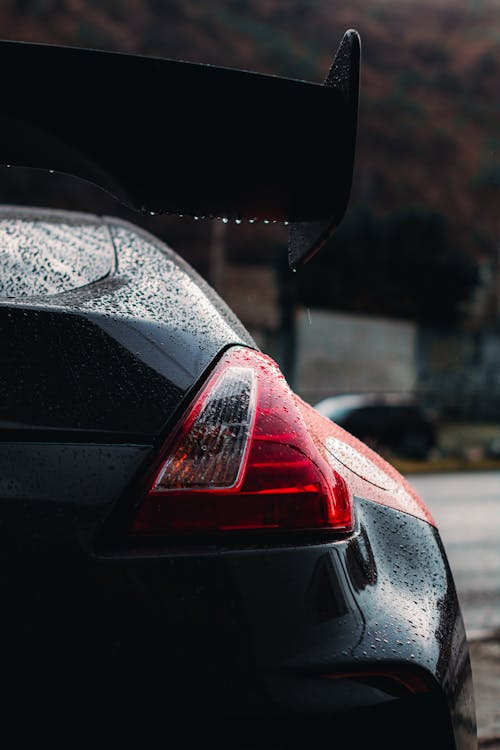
134 348 353 535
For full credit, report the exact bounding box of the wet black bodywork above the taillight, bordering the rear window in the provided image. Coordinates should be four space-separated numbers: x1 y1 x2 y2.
0 204 254 441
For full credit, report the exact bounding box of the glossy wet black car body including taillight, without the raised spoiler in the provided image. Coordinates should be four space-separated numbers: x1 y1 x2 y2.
0 208 476 750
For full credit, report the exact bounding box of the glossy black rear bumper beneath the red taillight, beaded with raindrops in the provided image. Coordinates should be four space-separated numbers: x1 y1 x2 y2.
3 500 475 750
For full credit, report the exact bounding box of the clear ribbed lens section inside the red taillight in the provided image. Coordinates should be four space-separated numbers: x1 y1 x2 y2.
153 367 255 492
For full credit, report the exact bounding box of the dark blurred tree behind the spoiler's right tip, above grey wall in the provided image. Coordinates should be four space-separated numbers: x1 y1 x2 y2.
296 208 478 328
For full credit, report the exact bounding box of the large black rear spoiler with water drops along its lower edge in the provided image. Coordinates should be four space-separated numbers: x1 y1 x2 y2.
0 31 360 267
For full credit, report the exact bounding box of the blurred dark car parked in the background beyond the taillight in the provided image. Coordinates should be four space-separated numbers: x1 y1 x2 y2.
314 393 436 459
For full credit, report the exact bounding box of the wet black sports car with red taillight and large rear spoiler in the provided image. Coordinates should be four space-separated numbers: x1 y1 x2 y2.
0 32 476 750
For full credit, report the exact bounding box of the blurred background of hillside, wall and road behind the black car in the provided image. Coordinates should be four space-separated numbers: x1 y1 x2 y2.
0 0 500 747
